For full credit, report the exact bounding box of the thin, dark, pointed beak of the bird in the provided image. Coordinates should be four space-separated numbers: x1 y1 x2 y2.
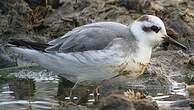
164 35 188 50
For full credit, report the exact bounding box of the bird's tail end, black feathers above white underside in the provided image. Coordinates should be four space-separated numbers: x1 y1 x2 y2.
4 39 53 64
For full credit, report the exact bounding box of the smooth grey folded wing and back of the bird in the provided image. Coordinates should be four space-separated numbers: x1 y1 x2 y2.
46 22 134 53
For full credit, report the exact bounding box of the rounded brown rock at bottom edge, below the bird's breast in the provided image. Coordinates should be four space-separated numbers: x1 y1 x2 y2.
99 92 159 110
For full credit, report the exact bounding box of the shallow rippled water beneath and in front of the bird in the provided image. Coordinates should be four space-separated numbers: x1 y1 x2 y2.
0 65 192 110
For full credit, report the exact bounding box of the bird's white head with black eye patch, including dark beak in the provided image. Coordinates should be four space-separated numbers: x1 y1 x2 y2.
131 15 187 50
